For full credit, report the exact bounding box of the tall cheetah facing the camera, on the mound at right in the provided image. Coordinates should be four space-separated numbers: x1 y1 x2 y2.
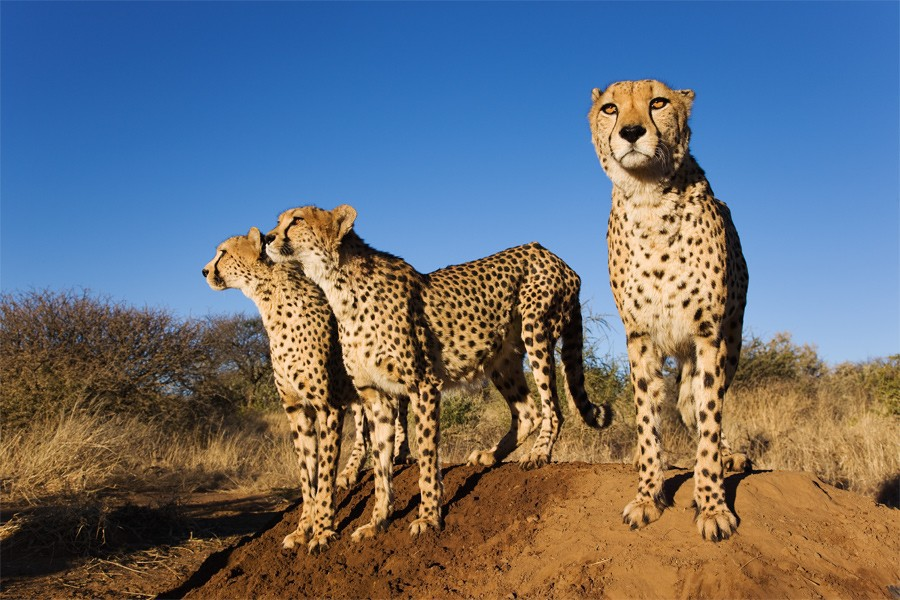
588 80 749 541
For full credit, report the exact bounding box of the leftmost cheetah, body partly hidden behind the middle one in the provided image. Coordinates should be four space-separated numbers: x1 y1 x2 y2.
203 227 409 553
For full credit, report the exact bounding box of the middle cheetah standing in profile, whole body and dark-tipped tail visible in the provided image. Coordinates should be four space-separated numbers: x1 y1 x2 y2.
266 205 611 539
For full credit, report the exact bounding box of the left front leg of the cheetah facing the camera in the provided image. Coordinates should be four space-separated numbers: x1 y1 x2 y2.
622 333 666 529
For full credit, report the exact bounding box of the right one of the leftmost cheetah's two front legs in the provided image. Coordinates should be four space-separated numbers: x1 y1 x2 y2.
308 406 344 554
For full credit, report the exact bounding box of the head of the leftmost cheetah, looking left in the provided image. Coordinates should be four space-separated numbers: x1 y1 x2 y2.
203 227 271 291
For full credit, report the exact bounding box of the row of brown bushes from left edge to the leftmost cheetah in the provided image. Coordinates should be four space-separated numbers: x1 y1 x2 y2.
0 290 275 428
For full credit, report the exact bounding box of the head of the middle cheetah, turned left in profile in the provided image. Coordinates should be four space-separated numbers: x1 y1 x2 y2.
266 204 356 279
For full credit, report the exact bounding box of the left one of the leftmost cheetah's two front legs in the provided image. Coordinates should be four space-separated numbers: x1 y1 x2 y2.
281 402 318 549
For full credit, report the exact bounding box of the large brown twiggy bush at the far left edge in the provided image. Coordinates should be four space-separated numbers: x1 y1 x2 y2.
0 290 201 426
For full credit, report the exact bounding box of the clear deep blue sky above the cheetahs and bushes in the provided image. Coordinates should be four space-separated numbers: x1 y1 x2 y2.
0 1 900 363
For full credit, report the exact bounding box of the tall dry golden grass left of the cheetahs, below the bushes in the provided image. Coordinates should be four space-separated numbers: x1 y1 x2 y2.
0 408 298 503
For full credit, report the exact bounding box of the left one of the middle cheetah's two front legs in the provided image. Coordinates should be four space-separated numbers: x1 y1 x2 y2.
350 388 397 542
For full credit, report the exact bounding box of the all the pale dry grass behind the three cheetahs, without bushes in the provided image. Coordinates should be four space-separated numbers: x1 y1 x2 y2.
0 372 900 504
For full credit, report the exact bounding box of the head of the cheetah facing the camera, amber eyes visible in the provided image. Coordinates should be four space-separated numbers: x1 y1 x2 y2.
588 79 694 186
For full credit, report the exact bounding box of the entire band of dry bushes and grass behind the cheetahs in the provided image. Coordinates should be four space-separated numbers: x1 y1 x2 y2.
0 292 900 572
